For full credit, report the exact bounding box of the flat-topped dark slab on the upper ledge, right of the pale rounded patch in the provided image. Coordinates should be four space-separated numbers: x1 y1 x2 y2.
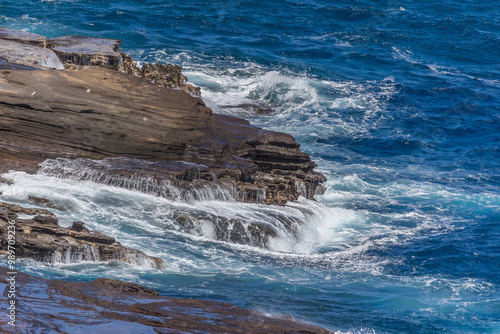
47 36 123 71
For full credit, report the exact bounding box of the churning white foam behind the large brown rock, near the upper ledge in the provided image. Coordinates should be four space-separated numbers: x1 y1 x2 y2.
139 50 397 138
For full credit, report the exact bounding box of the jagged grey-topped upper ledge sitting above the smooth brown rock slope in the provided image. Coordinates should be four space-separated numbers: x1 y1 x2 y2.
0 27 200 96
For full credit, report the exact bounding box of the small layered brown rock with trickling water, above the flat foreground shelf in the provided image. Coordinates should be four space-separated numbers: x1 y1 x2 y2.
0 202 163 269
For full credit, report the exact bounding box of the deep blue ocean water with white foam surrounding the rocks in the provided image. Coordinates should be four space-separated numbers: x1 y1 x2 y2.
0 0 500 333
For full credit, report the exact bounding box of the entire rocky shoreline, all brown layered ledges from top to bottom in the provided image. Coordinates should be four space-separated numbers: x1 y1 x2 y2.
0 28 327 333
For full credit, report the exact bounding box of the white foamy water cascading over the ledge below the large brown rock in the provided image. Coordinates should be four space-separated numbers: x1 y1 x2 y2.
0 172 378 268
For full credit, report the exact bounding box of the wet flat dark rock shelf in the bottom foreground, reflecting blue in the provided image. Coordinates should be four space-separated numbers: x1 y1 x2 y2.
0 267 332 334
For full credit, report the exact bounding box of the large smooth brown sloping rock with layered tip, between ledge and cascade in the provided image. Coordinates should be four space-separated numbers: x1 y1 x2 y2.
0 69 325 205
